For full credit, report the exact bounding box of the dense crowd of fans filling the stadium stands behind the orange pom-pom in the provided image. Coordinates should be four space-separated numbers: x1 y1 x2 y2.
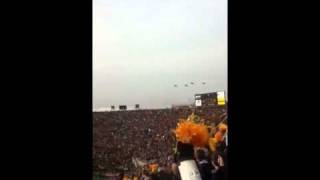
93 107 226 179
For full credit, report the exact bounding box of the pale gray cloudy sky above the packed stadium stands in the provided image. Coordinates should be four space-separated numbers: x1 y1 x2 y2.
93 0 227 109
